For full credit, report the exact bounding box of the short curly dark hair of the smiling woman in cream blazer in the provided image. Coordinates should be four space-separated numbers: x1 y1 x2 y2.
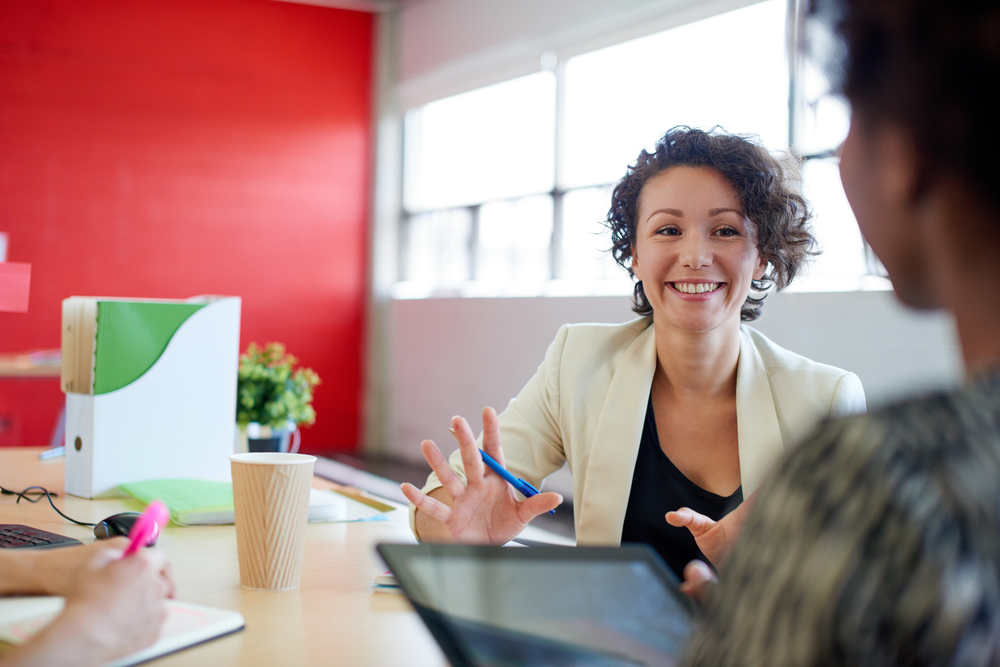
605 125 818 322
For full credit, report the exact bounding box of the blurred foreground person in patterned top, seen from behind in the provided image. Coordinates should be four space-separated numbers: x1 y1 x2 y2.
688 0 1000 667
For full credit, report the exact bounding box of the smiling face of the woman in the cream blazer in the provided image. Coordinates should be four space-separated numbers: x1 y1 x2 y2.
632 167 767 333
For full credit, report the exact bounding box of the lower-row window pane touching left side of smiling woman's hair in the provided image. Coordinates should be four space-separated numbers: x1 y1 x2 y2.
559 187 631 292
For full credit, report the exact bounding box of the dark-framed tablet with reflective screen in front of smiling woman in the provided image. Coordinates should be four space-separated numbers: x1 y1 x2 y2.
378 544 693 667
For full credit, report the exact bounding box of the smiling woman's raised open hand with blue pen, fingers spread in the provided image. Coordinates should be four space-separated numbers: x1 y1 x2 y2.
402 408 562 544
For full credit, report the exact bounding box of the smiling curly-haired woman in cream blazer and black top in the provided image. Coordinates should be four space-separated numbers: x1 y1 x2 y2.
403 127 864 575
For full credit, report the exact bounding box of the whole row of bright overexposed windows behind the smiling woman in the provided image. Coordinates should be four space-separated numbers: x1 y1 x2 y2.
396 0 885 298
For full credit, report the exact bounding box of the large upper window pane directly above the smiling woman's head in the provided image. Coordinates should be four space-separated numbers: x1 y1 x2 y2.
560 0 788 188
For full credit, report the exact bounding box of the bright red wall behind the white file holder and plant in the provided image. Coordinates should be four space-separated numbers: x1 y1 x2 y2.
0 0 373 453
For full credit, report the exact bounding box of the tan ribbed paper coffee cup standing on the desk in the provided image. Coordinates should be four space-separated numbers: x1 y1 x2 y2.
229 452 316 590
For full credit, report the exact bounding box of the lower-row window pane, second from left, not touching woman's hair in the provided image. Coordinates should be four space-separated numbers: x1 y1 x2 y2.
475 195 552 283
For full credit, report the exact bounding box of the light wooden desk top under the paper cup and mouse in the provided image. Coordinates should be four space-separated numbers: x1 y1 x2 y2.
0 447 448 667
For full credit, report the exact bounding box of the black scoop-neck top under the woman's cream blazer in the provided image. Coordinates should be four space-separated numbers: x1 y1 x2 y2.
622 398 743 579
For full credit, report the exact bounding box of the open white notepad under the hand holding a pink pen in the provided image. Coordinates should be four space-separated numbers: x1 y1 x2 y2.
0 596 245 667
